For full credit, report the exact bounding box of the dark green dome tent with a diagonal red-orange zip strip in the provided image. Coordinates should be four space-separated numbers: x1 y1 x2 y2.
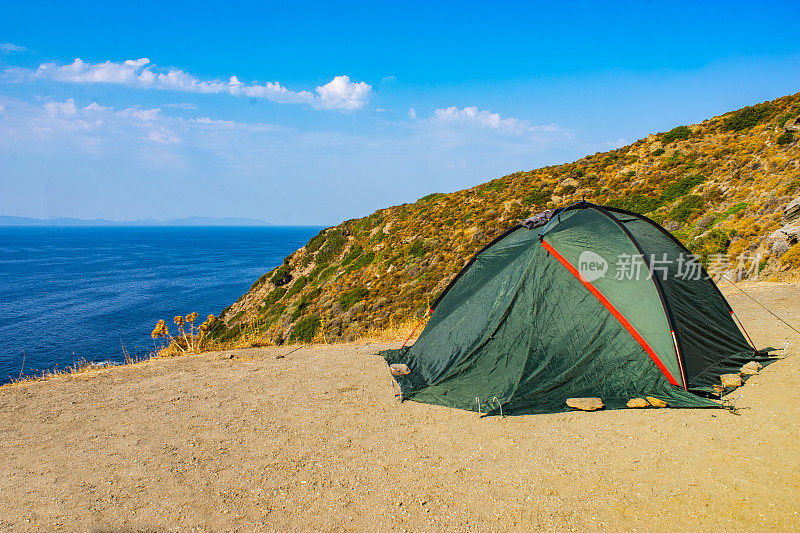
381 202 765 414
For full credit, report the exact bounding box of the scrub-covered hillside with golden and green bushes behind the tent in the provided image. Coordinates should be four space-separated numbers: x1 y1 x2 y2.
211 93 800 344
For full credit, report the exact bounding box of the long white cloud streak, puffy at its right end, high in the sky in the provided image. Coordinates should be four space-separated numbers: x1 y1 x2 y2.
6 57 372 111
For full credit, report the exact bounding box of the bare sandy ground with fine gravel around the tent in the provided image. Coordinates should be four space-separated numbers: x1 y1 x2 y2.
0 284 800 531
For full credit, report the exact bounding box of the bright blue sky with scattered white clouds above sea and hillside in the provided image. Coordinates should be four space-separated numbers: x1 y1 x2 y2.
0 0 800 224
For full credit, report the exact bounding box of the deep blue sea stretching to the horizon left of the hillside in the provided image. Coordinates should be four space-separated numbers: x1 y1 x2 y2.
0 227 320 383
